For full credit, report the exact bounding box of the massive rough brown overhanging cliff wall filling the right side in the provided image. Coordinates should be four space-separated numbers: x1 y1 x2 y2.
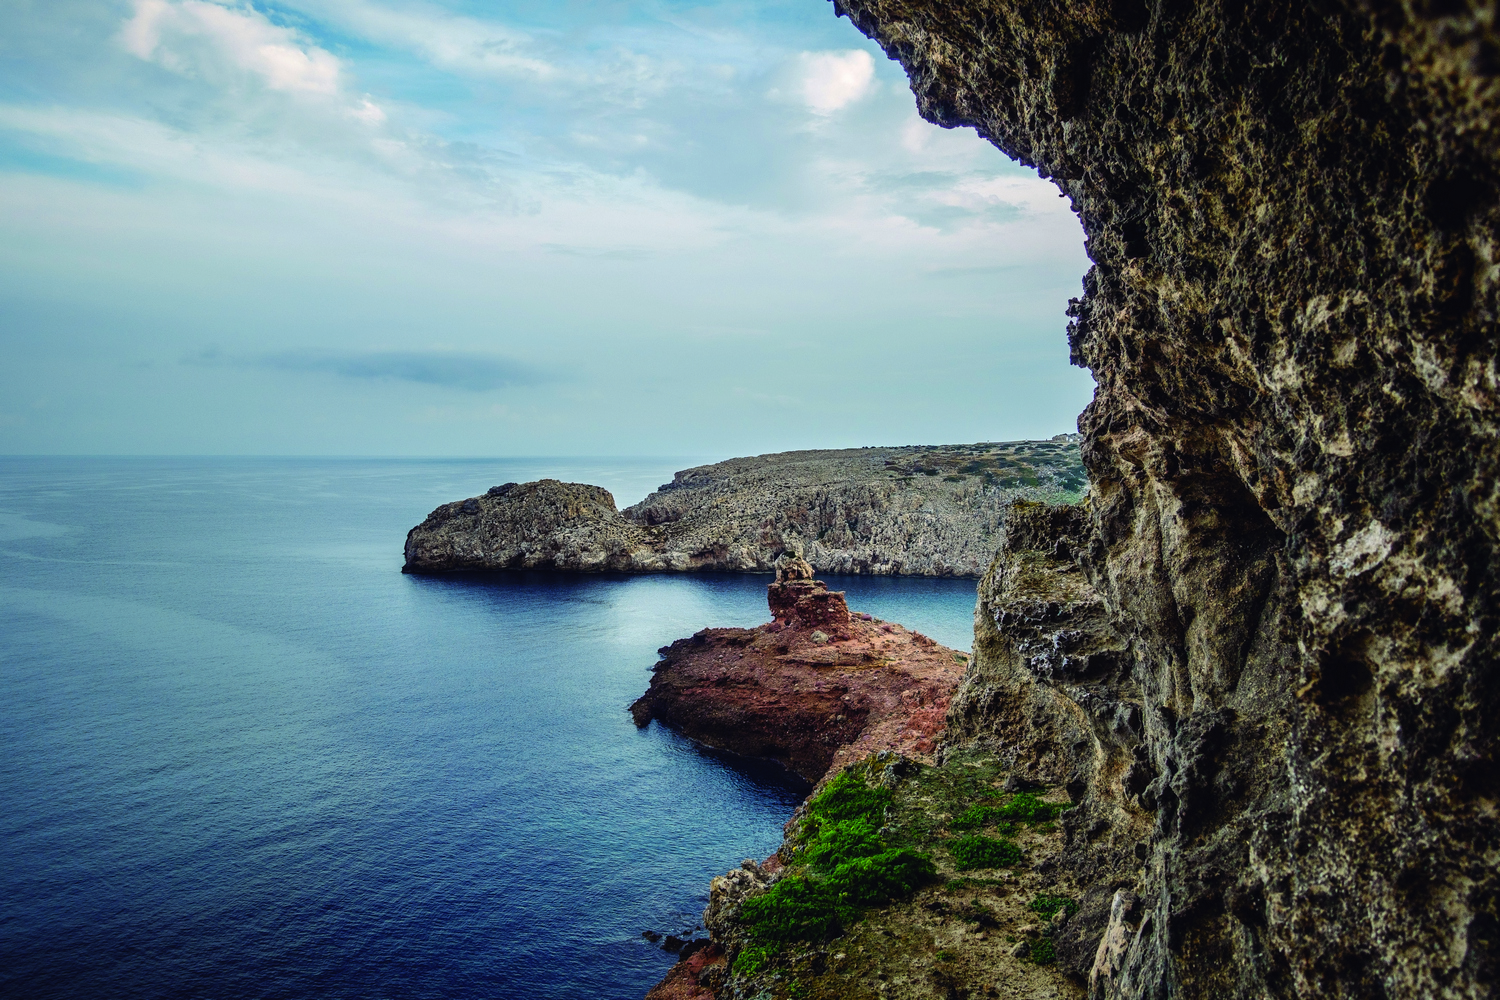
836 0 1500 997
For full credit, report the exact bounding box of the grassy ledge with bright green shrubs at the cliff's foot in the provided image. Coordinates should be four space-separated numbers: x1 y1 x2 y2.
704 751 1077 1000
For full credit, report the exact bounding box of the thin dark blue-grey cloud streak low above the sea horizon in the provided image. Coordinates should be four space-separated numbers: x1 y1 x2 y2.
183 348 546 393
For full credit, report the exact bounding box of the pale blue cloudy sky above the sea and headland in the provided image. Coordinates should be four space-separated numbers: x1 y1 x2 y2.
0 0 1094 457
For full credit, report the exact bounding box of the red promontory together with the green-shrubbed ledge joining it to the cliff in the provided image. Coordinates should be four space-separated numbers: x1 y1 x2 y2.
632 563 1082 1000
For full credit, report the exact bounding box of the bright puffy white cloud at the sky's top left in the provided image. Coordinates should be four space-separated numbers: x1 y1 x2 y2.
120 0 339 94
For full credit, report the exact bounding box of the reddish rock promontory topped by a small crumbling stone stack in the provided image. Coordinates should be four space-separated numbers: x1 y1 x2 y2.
630 556 969 784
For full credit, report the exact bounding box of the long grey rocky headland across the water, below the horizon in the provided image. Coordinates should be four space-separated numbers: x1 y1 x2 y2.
405 435 1086 577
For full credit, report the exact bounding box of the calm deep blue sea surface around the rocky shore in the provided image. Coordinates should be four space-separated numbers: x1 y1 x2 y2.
0 459 975 1000
